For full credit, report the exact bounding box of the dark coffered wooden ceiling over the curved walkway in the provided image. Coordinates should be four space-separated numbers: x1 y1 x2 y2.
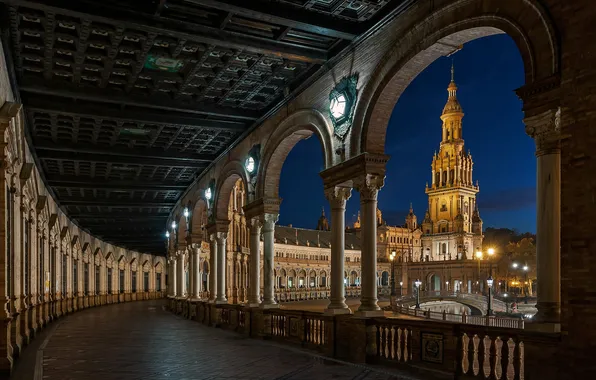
0 0 411 254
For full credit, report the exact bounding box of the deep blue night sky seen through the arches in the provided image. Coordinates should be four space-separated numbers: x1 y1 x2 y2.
279 35 536 232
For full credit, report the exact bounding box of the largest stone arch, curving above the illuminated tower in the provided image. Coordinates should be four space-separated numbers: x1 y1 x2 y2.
350 0 559 157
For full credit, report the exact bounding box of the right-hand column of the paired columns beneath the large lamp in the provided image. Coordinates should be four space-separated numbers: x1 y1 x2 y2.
356 174 385 317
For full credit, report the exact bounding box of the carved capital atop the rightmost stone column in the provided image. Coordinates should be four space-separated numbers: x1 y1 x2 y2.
524 107 562 156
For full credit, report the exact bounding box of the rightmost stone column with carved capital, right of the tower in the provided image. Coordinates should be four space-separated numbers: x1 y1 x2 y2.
524 108 561 323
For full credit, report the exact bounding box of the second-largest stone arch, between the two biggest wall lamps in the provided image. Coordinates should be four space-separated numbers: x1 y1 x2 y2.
256 109 334 199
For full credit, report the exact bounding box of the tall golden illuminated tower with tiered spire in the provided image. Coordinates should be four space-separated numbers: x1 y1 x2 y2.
423 66 482 260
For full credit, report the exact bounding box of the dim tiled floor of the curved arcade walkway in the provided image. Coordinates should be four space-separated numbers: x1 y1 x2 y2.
9 301 428 380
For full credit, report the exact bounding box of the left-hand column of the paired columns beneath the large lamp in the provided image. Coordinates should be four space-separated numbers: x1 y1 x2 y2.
324 187 352 314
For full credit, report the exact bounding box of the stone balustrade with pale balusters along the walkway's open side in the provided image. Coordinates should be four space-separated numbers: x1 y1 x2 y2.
168 298 561 379
